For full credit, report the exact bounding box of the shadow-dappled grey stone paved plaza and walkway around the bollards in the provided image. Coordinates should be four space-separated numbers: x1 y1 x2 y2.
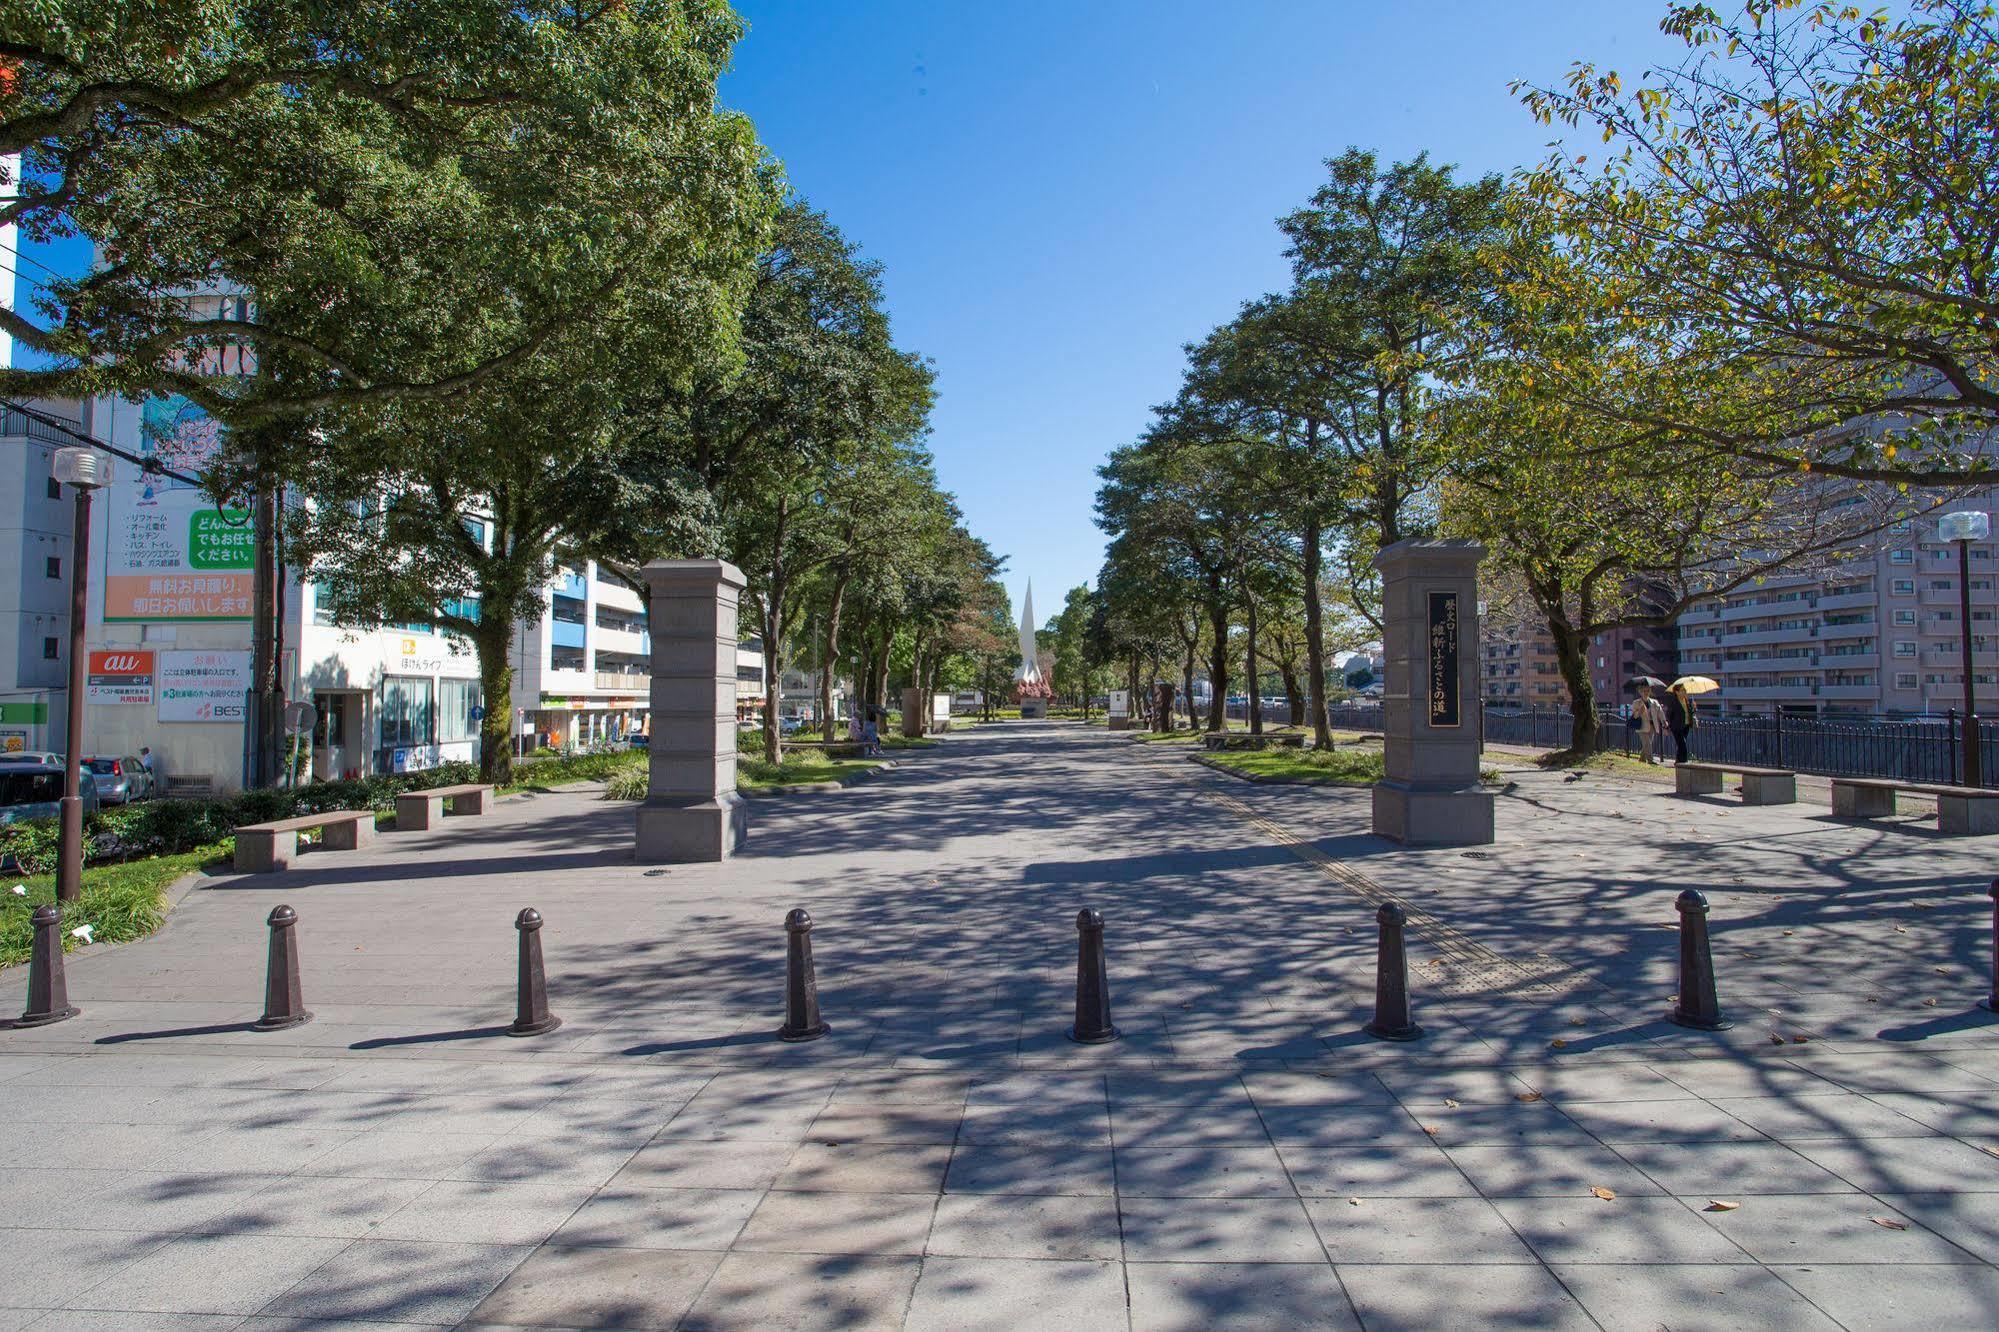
0 724 1999 1332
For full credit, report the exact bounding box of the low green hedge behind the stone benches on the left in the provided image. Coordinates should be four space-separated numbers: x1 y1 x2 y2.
0 752 644 874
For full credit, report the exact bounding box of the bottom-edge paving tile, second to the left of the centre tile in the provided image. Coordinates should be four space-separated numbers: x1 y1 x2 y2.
472 1246 722 1328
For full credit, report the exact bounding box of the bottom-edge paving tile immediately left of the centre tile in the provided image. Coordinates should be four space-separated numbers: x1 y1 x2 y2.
680 1254 922 1332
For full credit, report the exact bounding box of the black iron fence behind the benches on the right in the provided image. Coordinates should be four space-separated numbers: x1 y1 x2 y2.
1327 704 1999 788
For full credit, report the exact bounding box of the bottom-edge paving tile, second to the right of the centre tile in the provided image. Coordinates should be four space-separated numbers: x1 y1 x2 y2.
1335 1262 1595 1332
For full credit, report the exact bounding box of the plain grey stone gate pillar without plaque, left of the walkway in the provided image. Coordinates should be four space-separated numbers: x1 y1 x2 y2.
638 560 751 864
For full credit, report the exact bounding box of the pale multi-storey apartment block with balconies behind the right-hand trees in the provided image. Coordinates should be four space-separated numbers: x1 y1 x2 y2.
1679 504 1999 716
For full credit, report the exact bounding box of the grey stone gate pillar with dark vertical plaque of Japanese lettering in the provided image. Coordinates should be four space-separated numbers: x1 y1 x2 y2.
1373 538 1493 846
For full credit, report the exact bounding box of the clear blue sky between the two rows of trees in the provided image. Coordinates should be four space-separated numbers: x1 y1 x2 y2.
24 0 1675 616
